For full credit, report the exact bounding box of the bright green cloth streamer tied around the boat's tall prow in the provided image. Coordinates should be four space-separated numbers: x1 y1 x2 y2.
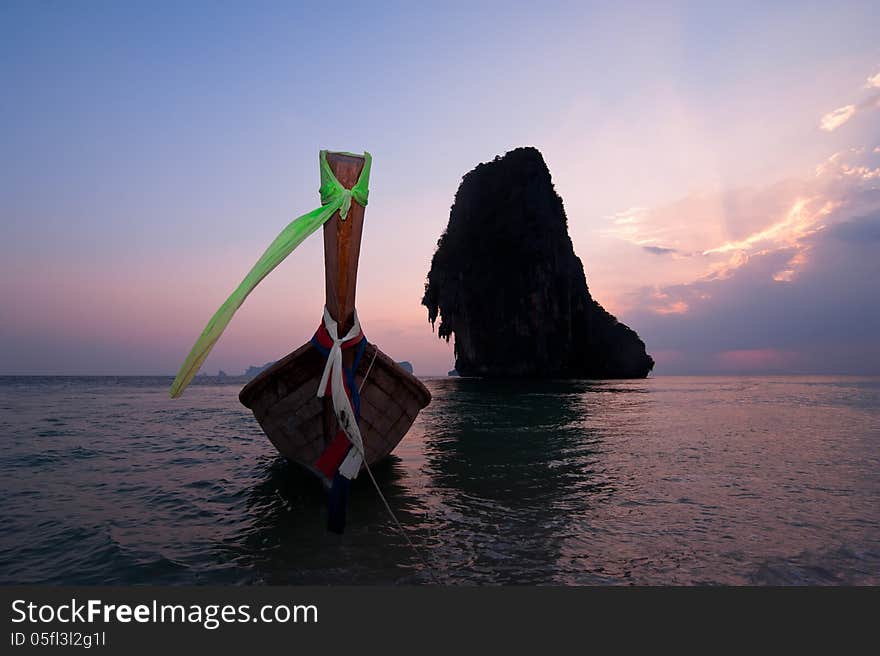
170 150 373 399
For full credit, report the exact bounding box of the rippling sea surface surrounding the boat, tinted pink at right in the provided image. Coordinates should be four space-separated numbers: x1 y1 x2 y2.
0 377 880 585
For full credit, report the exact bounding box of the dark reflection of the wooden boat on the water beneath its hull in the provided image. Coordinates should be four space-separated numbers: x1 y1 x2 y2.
223 457 434 584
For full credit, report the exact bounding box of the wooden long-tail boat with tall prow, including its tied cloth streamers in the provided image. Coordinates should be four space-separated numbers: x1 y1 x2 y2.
171 151 431 532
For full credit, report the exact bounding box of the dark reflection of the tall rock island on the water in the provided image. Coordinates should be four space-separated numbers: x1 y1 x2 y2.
422 379 615 583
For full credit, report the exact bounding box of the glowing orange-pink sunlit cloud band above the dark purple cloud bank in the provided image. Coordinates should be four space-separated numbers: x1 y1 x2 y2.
605 147 880 315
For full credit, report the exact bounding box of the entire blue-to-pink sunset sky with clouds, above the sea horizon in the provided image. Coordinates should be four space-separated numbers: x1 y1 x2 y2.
0 0 880 375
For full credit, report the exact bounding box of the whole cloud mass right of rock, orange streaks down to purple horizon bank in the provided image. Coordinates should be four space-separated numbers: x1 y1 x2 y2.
620 148 880 374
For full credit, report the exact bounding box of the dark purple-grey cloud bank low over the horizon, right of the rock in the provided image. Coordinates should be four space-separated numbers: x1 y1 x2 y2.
625 211 880 375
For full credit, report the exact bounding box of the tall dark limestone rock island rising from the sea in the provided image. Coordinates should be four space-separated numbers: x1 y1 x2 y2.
422 148 654 378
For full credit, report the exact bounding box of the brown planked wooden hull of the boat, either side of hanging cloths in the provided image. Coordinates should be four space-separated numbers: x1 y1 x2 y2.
239 342 431 484
